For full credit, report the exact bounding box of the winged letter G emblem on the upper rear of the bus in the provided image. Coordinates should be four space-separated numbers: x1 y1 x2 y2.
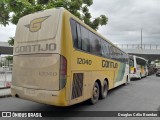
25 16 50 32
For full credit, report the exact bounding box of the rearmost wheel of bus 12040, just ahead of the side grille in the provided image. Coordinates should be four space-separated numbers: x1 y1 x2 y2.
89 82 100 105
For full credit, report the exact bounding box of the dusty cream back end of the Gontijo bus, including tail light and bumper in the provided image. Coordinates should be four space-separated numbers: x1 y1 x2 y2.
11 9 67 106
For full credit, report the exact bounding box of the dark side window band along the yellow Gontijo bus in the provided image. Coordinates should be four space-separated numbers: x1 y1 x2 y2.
70 19 128 63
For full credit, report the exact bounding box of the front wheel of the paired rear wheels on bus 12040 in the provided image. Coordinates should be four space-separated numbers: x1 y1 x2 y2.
100 80 108 99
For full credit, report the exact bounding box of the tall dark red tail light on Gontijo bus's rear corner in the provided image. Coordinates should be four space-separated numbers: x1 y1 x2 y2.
59 56 67 90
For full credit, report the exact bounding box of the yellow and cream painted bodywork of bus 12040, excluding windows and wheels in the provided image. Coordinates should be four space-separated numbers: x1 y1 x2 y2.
11 8 129 106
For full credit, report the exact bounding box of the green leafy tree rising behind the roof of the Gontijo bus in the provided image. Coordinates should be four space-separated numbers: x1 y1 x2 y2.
0 0 108 44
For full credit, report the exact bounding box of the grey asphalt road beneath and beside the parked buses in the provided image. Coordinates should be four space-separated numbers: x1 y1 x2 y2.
0 75 160 119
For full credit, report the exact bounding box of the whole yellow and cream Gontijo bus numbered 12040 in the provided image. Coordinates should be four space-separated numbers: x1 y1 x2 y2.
11 8 129 106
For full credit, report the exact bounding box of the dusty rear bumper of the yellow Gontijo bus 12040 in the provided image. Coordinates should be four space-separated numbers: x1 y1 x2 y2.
11 85 68 106
